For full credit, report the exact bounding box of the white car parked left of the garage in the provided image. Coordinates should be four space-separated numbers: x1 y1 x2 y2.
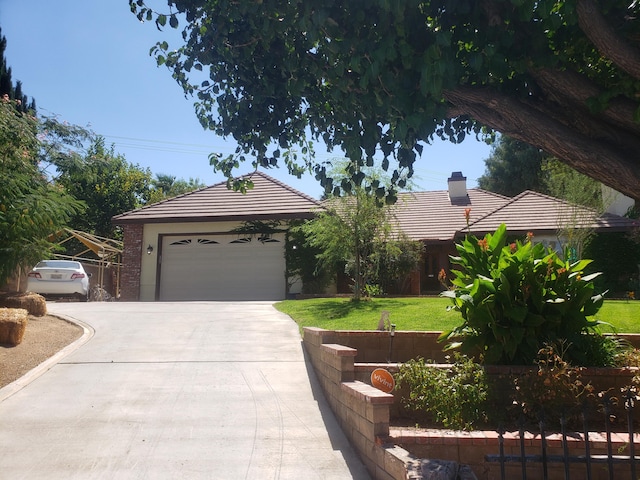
27 260 91 302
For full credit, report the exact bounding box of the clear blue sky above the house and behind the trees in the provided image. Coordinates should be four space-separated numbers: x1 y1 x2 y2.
0 0 491 198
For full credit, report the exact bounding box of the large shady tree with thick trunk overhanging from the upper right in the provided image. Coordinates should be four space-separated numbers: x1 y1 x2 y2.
130 0 640 198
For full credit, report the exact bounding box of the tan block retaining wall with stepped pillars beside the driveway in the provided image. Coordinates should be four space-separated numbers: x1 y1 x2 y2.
303 327 640 480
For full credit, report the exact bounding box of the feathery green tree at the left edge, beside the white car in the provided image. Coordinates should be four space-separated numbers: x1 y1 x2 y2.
0 100 81 285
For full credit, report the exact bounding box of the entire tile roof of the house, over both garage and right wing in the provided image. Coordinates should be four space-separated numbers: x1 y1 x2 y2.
113 172 640 242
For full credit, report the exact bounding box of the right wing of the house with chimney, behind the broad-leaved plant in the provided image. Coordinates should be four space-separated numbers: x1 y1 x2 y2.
396 172 639 294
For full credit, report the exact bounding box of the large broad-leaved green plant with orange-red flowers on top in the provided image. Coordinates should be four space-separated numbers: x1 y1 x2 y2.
442 225 603 365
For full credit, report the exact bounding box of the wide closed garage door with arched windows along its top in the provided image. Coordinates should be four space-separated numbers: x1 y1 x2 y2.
160 234 286 301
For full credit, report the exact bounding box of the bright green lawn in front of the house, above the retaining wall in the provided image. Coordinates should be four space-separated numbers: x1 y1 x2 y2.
275 297 640 333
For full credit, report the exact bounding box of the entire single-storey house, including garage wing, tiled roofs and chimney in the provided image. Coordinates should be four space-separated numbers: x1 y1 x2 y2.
113 172 637 301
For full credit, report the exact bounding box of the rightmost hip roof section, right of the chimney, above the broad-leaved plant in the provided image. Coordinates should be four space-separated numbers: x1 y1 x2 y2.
470 190 640 234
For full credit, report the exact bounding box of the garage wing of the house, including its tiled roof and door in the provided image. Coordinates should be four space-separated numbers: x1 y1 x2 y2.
113 172 320 301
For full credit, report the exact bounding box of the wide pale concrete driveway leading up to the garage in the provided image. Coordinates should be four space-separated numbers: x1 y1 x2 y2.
0 302 369 480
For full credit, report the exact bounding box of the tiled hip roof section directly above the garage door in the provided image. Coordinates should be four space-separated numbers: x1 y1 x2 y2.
112 172 320 225
